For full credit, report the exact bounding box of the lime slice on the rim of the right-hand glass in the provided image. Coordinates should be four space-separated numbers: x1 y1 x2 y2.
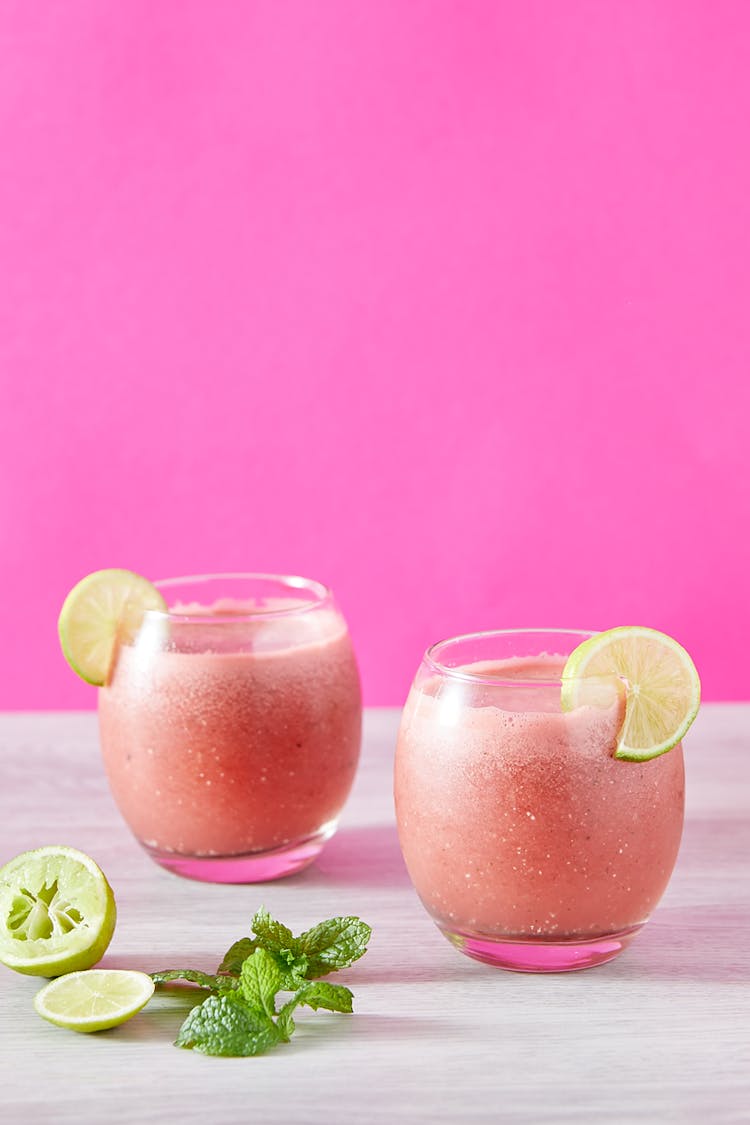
562 626 701 762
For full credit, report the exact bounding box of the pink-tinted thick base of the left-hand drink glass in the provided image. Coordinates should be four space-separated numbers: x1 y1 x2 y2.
142 824 336 883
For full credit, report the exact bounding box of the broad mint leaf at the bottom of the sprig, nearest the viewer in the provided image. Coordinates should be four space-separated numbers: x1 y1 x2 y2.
174 992 281 1056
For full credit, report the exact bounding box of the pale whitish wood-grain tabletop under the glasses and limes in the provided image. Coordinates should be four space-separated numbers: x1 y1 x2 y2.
0 704 750 1125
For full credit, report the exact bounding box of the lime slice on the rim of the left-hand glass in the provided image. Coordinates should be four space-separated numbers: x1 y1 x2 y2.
57 569 166 687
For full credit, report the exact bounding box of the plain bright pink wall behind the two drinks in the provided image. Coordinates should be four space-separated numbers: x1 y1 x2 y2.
0 0 750 709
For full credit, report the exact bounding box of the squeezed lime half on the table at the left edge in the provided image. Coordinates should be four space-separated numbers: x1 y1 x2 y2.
0 847 117 977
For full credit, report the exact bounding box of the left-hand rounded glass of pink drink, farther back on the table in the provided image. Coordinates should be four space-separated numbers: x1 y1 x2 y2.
99 574 362 883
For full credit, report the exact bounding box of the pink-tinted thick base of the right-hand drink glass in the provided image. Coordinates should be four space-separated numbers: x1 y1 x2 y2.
439 923 643 973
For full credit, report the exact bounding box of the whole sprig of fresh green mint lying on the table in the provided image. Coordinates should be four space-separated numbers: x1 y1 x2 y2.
151 907 372 1055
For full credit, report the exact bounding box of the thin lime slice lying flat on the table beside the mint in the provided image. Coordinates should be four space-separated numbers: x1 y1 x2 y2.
34 969 154 1032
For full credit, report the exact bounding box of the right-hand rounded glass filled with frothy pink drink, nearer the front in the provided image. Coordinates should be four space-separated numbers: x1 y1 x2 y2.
395 630 685 972
